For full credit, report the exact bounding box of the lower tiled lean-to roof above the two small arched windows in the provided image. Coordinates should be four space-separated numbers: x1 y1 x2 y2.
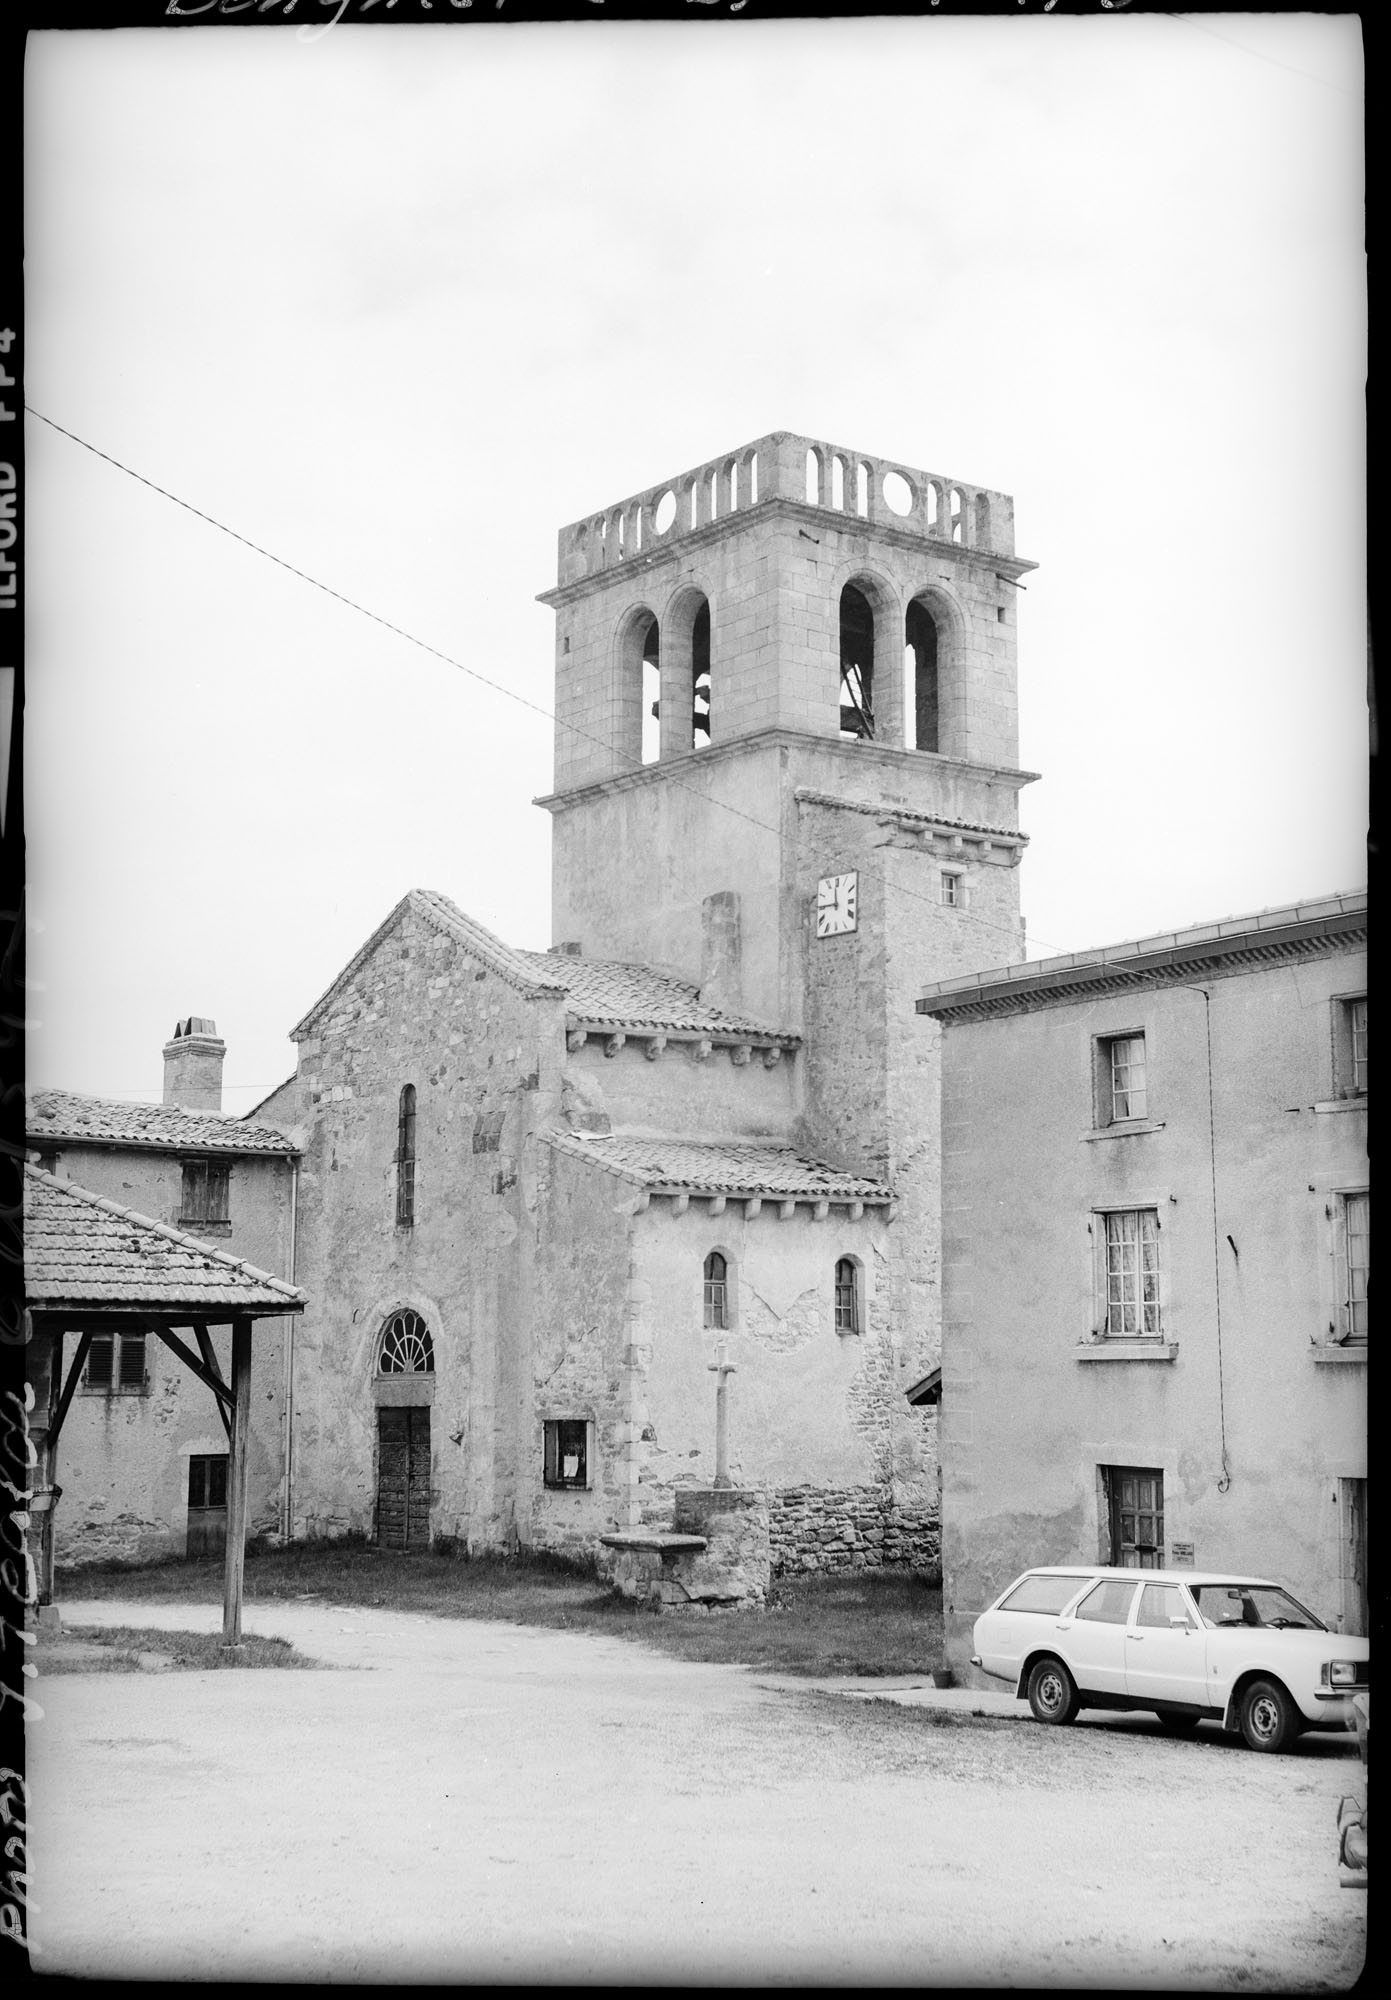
540 1132 893 1204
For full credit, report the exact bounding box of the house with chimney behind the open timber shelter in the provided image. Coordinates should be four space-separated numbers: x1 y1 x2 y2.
26 1016 296 1564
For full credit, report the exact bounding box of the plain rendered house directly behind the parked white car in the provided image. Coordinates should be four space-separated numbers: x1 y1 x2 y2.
919 896 1371 1670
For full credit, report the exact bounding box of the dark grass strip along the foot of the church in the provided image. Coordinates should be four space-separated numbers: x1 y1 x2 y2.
56 1538 941 1676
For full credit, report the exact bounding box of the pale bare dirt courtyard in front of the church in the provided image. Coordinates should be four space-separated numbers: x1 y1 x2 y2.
28 1602 1367 1992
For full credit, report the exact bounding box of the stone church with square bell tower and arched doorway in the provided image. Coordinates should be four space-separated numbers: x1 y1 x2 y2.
265 432 1031 1570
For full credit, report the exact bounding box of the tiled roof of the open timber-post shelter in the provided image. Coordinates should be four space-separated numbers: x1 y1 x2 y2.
24 1166 304 1320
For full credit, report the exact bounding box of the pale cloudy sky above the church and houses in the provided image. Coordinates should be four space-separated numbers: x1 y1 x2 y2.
26 14 1367 1110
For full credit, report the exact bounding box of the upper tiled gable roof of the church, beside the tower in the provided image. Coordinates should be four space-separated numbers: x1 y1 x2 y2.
290 888 801 1048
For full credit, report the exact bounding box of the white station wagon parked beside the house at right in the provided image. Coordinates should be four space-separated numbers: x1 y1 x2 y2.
971 1564 1367 1750
